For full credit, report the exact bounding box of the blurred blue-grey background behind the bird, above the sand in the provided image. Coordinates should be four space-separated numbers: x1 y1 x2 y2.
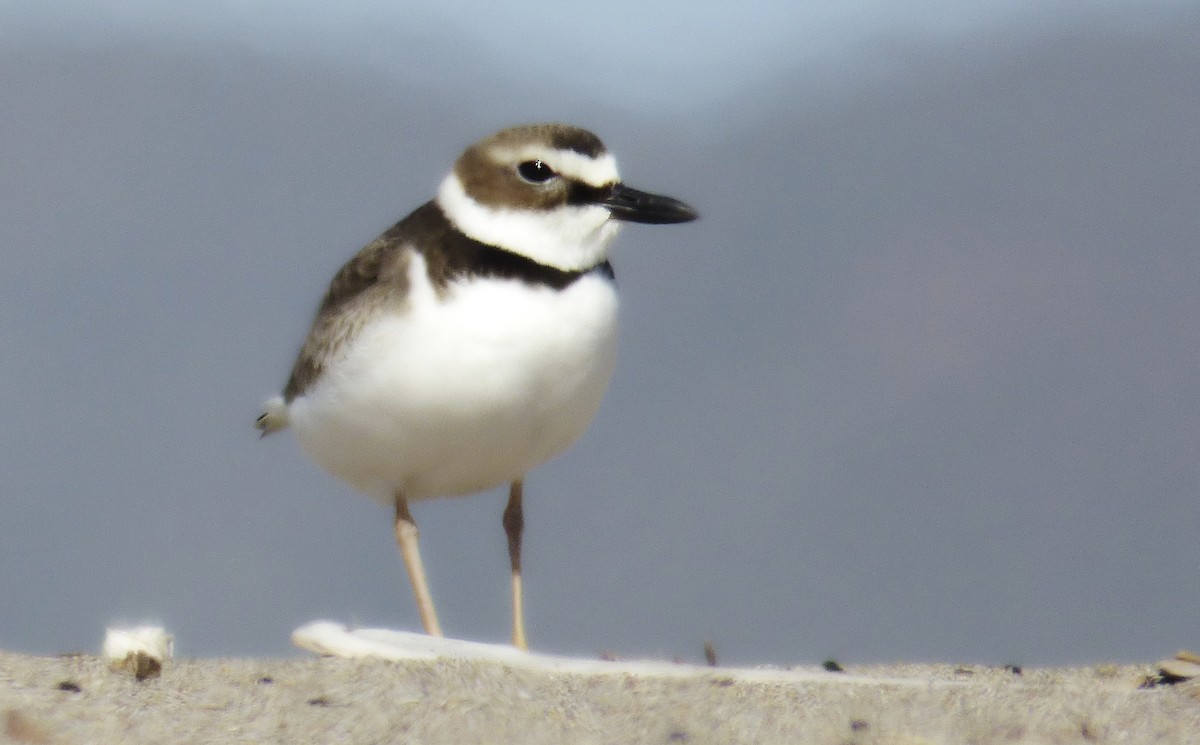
0 0 1200 665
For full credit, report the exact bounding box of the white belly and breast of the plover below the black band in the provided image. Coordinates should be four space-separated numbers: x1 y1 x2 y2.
288 258 617 504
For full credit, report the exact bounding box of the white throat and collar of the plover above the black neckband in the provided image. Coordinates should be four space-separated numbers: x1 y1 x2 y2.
437 172 620 271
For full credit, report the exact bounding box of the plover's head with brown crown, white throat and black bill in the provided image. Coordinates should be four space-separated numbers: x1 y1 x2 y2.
437 124 696 271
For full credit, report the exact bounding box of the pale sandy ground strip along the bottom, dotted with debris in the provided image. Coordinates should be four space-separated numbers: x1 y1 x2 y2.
0 651 1200 745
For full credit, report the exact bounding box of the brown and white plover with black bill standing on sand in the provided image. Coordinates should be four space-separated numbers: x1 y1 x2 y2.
256 124 697 650
